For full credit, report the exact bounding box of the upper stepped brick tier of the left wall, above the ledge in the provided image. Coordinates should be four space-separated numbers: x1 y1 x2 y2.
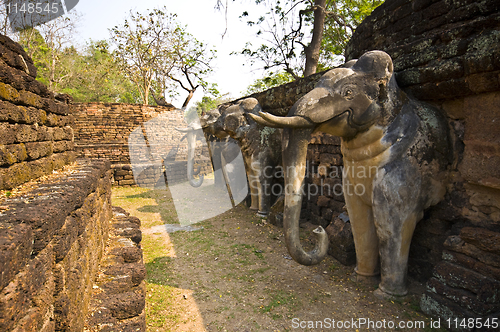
0 35 75 190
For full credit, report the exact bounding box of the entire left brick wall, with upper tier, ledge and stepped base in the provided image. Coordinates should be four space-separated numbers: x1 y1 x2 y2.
0 35 145 332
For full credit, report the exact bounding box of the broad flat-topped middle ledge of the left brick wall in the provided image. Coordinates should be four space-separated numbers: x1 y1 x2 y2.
0 161 111 331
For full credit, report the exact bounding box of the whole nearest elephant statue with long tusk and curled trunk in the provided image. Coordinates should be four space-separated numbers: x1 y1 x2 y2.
249 51 452 296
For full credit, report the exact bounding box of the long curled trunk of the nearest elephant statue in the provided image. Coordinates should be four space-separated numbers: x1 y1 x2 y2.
283 128 328 265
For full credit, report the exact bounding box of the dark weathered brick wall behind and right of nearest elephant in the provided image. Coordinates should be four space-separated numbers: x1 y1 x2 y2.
347 0 500 330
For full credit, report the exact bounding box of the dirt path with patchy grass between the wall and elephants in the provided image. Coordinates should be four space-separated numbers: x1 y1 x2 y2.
113 188 439 331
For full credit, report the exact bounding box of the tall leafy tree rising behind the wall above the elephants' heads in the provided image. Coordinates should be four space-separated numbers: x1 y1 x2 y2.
238 0 383 79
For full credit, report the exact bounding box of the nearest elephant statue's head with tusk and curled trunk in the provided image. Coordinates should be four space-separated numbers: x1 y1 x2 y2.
249 51 401 265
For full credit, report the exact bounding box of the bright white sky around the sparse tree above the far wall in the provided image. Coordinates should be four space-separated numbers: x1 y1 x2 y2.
74 0 263 106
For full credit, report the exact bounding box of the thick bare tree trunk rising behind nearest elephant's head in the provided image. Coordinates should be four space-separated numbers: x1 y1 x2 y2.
304 0 326 77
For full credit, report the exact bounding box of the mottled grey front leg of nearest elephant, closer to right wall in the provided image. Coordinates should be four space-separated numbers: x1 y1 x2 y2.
373 166 423 296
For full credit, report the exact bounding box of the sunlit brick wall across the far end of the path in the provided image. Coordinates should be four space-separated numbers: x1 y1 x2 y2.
74 103 211 188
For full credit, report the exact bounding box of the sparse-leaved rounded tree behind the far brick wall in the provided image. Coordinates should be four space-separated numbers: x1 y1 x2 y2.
111 7 214 108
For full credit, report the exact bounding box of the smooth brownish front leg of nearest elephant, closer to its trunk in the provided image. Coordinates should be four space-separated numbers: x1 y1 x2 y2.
343 177 380 277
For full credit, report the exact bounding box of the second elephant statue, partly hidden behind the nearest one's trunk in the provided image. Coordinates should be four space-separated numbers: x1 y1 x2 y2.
214 98 281 217
